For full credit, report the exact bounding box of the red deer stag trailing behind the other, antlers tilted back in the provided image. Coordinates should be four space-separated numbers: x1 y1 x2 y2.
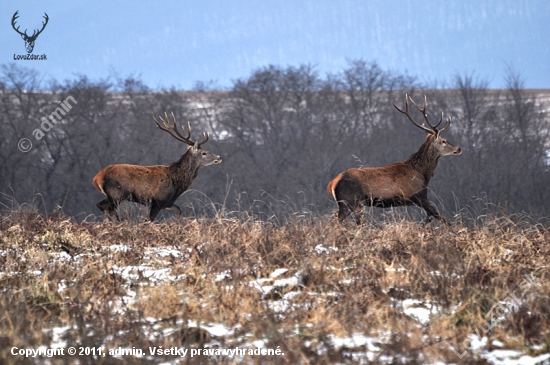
93 113 222 221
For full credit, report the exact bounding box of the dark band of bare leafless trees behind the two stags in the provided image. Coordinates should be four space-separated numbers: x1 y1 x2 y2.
0 60 550 218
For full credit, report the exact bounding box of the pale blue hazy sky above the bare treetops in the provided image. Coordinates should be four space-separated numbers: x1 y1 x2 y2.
0 0 550 88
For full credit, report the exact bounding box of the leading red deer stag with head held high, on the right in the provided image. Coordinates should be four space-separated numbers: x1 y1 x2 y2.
327 94 460 225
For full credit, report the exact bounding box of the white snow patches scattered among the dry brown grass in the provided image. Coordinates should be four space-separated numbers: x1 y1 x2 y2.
0 239 550 365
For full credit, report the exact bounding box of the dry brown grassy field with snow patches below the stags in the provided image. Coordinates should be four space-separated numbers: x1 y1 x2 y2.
0 211 550 364
